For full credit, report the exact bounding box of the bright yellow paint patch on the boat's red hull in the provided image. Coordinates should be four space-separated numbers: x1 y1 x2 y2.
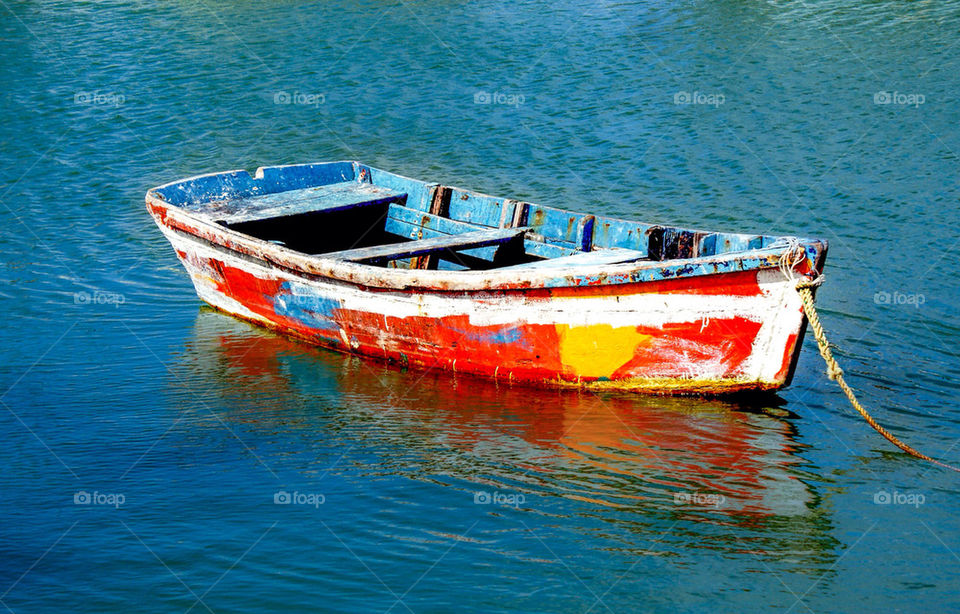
557 324 651 377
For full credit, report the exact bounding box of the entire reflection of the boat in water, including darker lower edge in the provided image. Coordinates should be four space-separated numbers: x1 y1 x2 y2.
181 308 832 556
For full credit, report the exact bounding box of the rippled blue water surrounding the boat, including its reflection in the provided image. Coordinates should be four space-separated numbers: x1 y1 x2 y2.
0 0 960 614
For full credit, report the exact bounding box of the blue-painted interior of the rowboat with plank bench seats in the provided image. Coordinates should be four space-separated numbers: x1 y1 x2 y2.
150 162 782 270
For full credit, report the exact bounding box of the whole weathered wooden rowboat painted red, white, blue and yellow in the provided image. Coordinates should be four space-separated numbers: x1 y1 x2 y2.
146 162 827 395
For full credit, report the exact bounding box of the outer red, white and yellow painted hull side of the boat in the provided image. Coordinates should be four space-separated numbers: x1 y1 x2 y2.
158 225 805 395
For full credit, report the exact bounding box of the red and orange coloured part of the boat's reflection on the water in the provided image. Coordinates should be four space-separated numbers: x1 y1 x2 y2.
192 312 811 520
